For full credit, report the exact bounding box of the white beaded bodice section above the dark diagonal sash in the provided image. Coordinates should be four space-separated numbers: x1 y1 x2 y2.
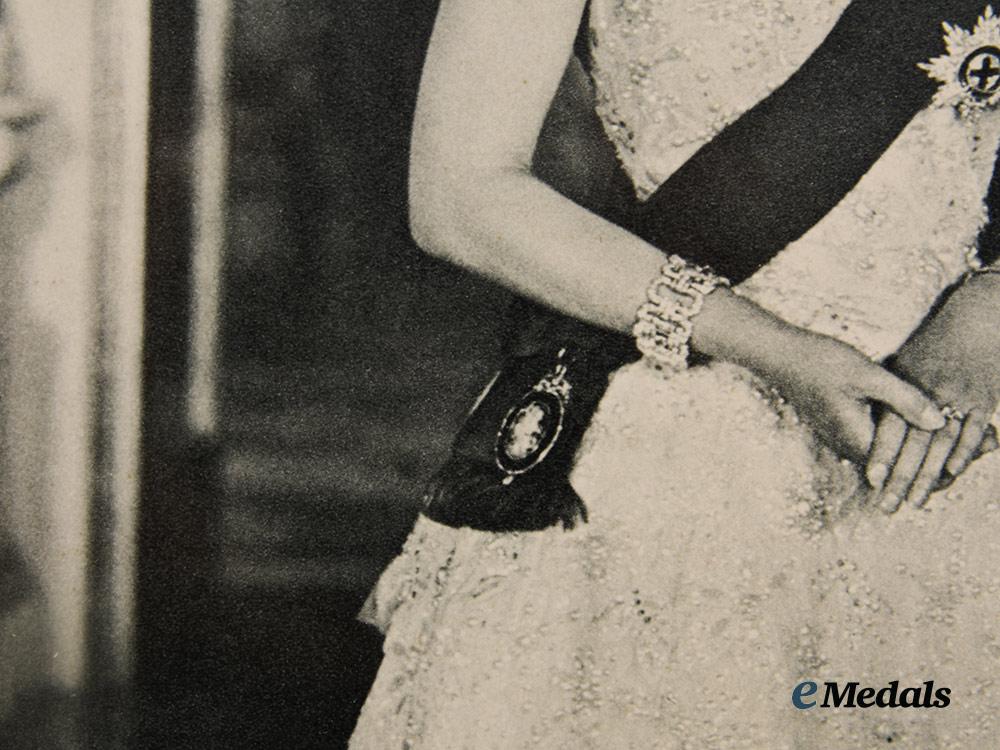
591 0 847 197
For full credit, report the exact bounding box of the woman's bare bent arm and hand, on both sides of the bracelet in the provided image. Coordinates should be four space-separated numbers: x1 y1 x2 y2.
410 0 939 454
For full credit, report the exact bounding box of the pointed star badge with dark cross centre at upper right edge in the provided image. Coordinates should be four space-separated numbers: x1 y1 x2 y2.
918 5 1000 116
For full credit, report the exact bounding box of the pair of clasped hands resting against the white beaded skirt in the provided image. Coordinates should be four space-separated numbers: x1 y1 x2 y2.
761 274 1000 512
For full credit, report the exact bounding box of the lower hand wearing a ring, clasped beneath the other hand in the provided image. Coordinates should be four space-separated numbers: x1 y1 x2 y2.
866 274 1000 512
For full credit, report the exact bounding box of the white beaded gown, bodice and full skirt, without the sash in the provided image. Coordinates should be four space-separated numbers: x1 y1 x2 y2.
351 0 1000 750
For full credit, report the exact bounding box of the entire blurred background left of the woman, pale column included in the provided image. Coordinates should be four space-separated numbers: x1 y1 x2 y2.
0 0 507 750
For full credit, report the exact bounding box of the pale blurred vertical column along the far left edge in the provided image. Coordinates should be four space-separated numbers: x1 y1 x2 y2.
0 0 149 736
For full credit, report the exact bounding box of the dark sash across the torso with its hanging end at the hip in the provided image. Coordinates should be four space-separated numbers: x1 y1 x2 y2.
424 0 1000 531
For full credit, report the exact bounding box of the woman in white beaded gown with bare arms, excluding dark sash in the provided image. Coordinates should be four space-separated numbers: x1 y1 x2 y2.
351 0 1000 750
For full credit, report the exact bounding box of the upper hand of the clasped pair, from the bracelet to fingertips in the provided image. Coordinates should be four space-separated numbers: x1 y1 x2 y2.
691 289 945 465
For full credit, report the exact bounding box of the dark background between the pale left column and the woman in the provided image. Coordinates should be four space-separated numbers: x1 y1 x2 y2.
136 0 504 749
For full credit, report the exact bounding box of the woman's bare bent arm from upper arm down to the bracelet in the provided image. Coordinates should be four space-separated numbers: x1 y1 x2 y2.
410 0 663 330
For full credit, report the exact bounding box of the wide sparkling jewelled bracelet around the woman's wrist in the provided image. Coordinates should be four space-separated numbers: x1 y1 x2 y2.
632 255 729 372
